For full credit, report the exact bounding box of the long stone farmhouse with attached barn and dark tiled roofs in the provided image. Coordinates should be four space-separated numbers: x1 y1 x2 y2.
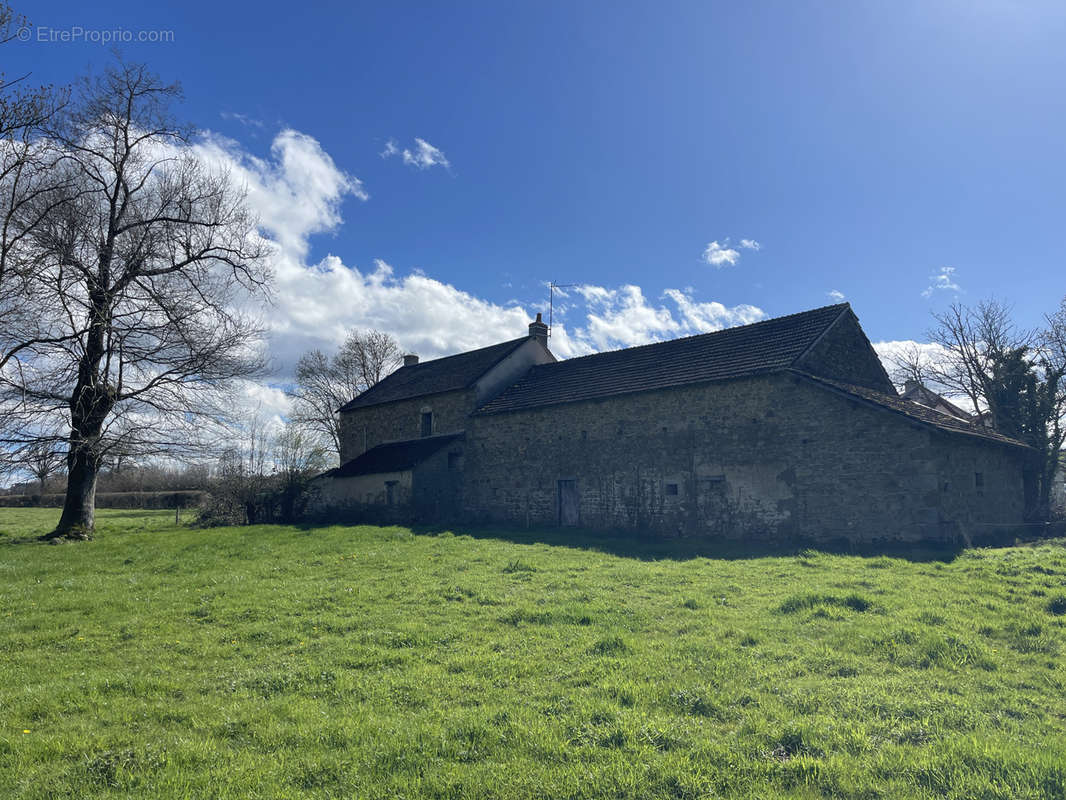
316 303 1030 541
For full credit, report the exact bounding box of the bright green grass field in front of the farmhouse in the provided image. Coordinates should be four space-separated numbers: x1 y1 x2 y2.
0 509 1066 799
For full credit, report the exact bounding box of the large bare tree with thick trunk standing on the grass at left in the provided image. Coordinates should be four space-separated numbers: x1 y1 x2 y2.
0 64 269 538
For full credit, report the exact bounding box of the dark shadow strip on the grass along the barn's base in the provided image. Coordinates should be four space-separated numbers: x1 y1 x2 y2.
392 525 965 562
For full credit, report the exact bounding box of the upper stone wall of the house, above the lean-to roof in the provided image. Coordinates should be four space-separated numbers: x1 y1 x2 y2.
340 389 474 464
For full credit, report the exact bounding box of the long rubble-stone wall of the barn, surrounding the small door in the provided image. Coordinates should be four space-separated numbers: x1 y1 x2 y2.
464 375 1022 541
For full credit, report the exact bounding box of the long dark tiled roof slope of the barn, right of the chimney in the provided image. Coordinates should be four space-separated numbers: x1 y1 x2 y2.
478 303 850 414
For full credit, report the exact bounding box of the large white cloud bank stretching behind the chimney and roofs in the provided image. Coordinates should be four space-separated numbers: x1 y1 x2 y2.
197 130 765 386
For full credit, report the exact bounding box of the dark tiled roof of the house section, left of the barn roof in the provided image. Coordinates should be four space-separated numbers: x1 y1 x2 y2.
340 336 529 411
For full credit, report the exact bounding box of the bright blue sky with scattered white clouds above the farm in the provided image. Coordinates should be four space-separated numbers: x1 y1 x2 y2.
3 0 1066 371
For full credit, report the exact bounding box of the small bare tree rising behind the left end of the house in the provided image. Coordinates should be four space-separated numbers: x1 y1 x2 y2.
290 331 403 455
